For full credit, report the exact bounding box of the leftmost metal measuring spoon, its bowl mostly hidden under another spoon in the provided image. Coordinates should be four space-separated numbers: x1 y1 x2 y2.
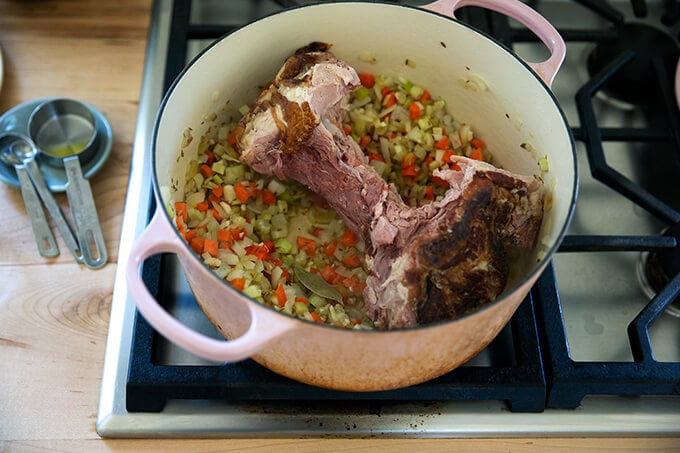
0 135 59 258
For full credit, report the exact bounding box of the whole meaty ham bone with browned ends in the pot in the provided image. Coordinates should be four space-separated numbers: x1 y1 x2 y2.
236 43 543 329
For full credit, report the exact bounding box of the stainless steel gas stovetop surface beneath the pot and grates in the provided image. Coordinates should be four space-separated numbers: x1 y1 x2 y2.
97 0 680 437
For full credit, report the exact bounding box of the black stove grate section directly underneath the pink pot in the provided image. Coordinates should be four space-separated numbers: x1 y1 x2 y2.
126 256 546 412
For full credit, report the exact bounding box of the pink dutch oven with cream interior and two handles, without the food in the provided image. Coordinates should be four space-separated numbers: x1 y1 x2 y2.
126 0 577 391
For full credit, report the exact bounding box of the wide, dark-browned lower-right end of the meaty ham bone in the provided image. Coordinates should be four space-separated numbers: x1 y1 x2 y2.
364 157 543 328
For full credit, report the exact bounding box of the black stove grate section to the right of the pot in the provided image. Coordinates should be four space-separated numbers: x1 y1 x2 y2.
537 10 680 408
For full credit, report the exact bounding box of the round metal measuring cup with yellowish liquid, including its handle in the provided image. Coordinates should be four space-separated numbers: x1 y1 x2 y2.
28 98 108 268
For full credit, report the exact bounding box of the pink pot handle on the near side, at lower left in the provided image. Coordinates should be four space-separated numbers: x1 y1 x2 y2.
125 209 295 362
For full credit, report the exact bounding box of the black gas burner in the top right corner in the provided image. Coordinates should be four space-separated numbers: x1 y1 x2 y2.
587 23 680 106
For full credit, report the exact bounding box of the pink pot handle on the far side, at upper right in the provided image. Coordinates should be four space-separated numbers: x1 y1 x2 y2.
422 0 567 87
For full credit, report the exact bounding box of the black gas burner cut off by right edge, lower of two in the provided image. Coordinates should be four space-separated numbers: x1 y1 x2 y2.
640 224 680 317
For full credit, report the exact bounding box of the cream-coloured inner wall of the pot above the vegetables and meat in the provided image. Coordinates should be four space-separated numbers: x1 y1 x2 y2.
154 3 576 284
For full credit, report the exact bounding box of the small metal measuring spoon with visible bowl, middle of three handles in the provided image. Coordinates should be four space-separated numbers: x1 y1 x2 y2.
5 134 83 263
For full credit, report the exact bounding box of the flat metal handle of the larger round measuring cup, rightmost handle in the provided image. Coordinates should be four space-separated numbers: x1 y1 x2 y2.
64 156 108 269
